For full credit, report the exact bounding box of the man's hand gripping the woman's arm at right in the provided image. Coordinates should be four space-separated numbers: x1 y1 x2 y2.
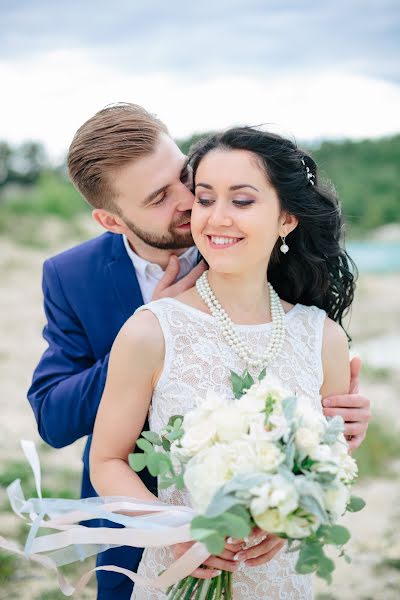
322 356 371 450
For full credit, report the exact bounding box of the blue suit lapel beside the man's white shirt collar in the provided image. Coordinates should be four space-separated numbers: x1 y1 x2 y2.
106 234 143 319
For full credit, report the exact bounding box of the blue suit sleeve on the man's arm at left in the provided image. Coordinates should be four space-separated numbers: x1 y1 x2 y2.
28 261 109 448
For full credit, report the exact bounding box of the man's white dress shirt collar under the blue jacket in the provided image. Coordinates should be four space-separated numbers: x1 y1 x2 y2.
122 235 198 304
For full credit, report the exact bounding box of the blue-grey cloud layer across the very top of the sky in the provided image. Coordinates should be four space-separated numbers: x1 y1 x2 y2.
0 0 400 82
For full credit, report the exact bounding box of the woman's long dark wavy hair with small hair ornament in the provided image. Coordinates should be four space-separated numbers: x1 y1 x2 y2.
189 127 357 336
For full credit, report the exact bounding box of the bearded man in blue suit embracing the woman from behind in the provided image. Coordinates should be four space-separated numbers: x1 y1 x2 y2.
28 104 370 600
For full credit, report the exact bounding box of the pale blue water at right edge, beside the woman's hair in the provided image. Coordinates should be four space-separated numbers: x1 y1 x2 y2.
346 241 400 273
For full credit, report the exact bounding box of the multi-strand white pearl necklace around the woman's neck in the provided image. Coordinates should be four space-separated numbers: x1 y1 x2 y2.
196 271 285 368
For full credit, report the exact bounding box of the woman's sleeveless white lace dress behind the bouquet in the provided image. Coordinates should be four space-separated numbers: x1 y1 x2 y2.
131 298 326 600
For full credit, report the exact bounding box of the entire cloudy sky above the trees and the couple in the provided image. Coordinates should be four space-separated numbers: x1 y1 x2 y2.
0 0 400 160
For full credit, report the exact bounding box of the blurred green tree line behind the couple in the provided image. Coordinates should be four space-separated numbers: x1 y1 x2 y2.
0 133 400 236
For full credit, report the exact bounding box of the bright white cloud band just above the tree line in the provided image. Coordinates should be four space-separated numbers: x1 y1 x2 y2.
0 50 400 158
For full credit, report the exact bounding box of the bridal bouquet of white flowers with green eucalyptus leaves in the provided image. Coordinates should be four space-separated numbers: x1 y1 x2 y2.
129 370 365 600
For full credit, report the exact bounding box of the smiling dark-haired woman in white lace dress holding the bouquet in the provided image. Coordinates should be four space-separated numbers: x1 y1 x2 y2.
90 127 354 600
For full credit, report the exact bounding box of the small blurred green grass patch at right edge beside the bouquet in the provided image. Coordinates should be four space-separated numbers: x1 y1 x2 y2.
353 419 400 479
